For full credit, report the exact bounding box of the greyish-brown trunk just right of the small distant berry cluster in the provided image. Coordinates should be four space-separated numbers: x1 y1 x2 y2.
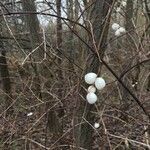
119 0 135 126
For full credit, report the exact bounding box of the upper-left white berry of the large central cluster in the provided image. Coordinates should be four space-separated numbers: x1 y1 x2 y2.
84 72 97 84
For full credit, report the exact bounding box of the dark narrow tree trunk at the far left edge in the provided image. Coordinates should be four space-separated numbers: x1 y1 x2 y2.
0 8 14 150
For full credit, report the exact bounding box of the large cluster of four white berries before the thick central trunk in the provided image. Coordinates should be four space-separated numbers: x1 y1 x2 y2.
84 72 106 104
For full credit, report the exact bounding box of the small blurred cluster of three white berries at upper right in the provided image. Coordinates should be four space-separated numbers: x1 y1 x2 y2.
111 23 126 36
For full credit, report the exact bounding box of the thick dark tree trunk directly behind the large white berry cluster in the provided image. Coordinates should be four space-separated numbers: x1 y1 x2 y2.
74 0 113 150
